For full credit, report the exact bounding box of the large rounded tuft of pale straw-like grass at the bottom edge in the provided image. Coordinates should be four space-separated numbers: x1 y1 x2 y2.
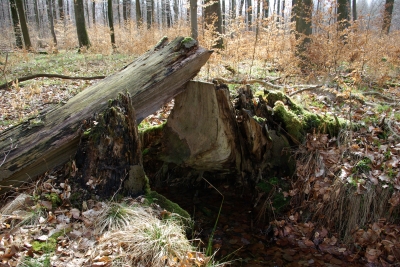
99 207 198 267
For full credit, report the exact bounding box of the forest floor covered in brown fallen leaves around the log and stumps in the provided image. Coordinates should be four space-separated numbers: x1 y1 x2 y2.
0 48 400 267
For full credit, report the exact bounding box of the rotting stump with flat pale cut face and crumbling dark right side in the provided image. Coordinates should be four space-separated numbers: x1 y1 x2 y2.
143 81 289 182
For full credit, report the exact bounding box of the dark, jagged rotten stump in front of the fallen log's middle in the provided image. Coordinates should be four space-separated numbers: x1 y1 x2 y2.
71 94 148 199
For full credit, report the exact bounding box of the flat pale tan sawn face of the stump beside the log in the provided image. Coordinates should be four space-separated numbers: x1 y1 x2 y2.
161 81 240 171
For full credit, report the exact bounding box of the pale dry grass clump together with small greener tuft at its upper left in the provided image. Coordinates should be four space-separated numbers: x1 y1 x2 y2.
94 203 208 267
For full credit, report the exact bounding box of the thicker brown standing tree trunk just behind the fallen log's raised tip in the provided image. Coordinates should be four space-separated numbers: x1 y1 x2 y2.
204 0 223 48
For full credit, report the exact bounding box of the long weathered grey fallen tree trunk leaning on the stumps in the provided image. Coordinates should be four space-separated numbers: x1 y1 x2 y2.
0 37 212 193
